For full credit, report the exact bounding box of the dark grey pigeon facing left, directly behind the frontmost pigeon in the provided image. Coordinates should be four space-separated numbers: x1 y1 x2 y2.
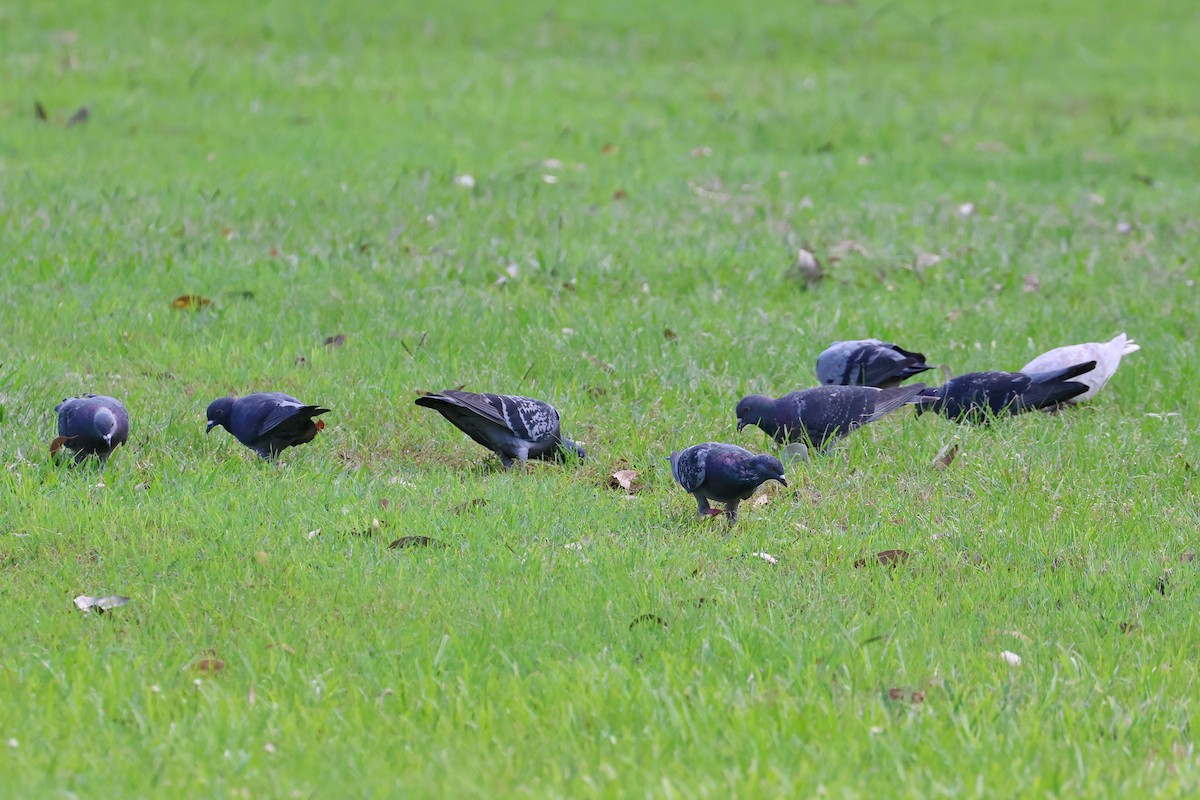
736 384 925 450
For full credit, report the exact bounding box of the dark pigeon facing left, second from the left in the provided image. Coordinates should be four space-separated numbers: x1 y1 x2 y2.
205 392 329 458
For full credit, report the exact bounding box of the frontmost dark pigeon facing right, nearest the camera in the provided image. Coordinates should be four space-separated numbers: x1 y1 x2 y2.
671 441 787 525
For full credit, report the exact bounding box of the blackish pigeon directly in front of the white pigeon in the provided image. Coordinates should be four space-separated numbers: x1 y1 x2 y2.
918 361 1096 423
